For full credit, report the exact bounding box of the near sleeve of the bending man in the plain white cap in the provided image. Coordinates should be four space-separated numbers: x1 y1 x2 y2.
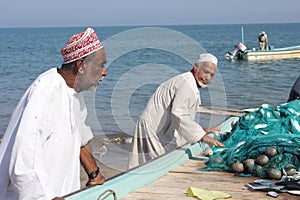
171 82 206 144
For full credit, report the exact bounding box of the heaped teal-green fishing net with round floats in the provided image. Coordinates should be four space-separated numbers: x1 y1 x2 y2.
204 100 300 179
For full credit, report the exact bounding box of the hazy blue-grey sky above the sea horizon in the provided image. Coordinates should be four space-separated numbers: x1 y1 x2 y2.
0 0 300 27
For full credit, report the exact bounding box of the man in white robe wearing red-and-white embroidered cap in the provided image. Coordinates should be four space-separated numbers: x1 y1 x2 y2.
0 28 107 199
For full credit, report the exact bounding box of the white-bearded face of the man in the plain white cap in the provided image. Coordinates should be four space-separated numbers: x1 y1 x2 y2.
194 62 217 87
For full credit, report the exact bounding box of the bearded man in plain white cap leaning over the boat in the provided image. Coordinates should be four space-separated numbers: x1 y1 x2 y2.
128 53 224 169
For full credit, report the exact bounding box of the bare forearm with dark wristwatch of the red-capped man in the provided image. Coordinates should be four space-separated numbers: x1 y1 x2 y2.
80 144 105 186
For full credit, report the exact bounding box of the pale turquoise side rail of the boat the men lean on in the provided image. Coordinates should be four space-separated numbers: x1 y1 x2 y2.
64 116 238 200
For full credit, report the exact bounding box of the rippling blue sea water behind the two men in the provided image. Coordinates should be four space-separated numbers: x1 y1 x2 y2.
0 24 300 135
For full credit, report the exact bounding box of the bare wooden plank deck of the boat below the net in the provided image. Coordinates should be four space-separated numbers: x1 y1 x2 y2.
122 160 300 200
